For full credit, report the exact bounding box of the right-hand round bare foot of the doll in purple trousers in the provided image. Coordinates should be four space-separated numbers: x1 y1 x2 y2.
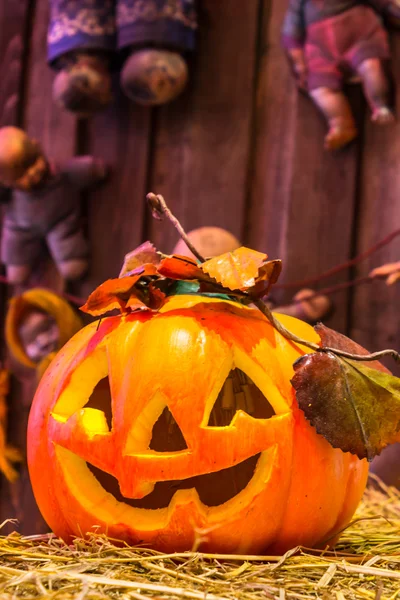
121 50 188 106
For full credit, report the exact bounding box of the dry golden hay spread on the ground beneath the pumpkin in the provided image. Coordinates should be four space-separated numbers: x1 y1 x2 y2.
0 478 400 600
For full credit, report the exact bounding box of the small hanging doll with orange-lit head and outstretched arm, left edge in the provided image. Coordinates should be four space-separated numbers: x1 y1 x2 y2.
0 127 106 284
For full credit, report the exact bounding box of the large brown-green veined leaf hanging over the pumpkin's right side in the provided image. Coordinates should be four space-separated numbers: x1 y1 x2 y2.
292 352 400 460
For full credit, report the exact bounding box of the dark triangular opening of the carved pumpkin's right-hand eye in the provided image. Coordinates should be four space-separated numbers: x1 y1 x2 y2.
208 369 275 427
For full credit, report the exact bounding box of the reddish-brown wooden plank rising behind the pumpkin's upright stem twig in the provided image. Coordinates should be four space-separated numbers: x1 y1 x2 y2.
147 0 259 252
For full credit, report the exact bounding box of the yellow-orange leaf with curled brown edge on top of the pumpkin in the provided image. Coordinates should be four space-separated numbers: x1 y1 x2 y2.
200 247 281 295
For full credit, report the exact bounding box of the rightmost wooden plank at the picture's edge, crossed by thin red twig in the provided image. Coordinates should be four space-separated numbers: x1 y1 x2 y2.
351 31 400 373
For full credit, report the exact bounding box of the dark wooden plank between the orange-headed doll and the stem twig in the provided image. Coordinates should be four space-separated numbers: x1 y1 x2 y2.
74 91 151 296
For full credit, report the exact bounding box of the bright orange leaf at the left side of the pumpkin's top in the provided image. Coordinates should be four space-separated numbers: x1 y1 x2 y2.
81 264 157 317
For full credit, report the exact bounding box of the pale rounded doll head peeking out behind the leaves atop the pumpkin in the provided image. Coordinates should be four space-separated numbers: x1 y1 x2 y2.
172 227 241 258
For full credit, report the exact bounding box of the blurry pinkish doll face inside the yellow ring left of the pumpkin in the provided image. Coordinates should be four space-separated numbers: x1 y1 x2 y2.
18 308 60 363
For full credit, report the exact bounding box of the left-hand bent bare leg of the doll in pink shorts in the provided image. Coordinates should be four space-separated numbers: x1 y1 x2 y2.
310 87 357 150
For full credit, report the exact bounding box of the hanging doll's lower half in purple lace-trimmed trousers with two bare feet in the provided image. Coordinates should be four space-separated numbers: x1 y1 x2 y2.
48 0 197 117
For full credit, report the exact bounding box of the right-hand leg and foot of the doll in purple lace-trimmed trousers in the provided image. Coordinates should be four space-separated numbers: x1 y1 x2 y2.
117 0 197 105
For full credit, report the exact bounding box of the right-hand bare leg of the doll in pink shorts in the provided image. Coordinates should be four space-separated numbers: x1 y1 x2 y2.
357 58 394 125
